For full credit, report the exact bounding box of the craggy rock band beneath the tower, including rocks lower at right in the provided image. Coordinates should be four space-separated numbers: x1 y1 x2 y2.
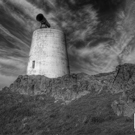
3 64 135 115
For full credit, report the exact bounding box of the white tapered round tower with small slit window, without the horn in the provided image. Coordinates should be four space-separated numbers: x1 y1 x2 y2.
27 28 69 78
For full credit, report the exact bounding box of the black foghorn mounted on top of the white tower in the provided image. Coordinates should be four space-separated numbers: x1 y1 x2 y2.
36 14 51 28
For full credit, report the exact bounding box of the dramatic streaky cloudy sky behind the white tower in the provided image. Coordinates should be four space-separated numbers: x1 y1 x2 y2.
0 0 135 88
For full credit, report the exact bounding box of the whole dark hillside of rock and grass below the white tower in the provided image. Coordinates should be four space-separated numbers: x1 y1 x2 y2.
0 64 135 135
